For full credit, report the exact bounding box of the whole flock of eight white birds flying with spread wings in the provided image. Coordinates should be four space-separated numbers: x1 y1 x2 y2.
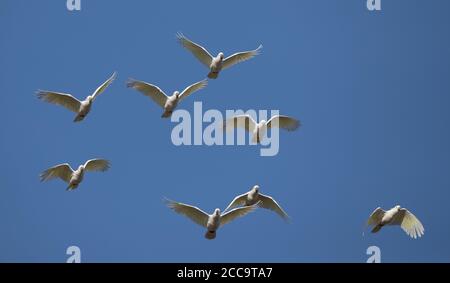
37 33 424 239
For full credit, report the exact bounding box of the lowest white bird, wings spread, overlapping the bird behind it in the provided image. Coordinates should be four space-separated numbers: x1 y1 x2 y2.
166 200 257 240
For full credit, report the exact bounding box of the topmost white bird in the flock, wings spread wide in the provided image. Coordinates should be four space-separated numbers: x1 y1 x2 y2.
177 33 262 79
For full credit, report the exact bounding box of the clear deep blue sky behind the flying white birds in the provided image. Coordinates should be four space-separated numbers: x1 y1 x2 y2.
0 0 450 262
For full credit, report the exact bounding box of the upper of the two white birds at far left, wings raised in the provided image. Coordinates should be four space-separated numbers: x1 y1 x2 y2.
37 72 116 122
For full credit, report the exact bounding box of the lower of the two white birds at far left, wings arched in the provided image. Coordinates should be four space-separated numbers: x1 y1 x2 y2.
40 159 110 191
